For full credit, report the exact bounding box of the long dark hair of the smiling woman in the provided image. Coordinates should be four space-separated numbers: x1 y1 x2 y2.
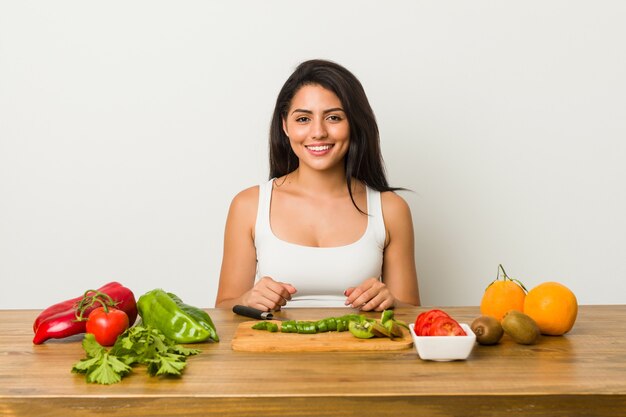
269 59 402 211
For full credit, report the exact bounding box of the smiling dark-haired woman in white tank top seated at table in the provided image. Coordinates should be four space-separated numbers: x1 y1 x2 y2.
216 60 420 311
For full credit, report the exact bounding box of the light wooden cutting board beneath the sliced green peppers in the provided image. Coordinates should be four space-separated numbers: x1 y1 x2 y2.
231 321 413 352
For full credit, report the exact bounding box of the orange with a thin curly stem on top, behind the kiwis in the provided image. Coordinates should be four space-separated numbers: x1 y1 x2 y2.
480 265 526 321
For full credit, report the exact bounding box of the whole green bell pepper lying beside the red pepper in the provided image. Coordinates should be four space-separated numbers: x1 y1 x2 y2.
137 289 219 343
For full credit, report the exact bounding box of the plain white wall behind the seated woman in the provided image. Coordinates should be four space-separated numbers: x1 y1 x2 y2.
0 0 626 308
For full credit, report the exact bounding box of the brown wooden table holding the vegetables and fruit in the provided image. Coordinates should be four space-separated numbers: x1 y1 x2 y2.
0 305 626 417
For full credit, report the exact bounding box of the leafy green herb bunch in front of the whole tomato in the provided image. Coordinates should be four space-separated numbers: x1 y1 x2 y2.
72 325 200 385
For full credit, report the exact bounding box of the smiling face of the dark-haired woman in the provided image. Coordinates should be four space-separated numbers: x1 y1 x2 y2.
283 84 350 175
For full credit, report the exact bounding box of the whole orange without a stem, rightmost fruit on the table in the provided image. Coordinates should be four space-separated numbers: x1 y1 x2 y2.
524 282 578 336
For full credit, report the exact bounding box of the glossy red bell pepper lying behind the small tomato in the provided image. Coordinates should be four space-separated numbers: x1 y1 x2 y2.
33 282 137 345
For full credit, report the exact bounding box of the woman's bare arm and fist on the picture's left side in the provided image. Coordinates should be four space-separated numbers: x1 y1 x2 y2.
215 186 295 310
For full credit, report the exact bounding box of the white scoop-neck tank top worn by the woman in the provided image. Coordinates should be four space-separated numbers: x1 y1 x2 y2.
254 180 386 307
